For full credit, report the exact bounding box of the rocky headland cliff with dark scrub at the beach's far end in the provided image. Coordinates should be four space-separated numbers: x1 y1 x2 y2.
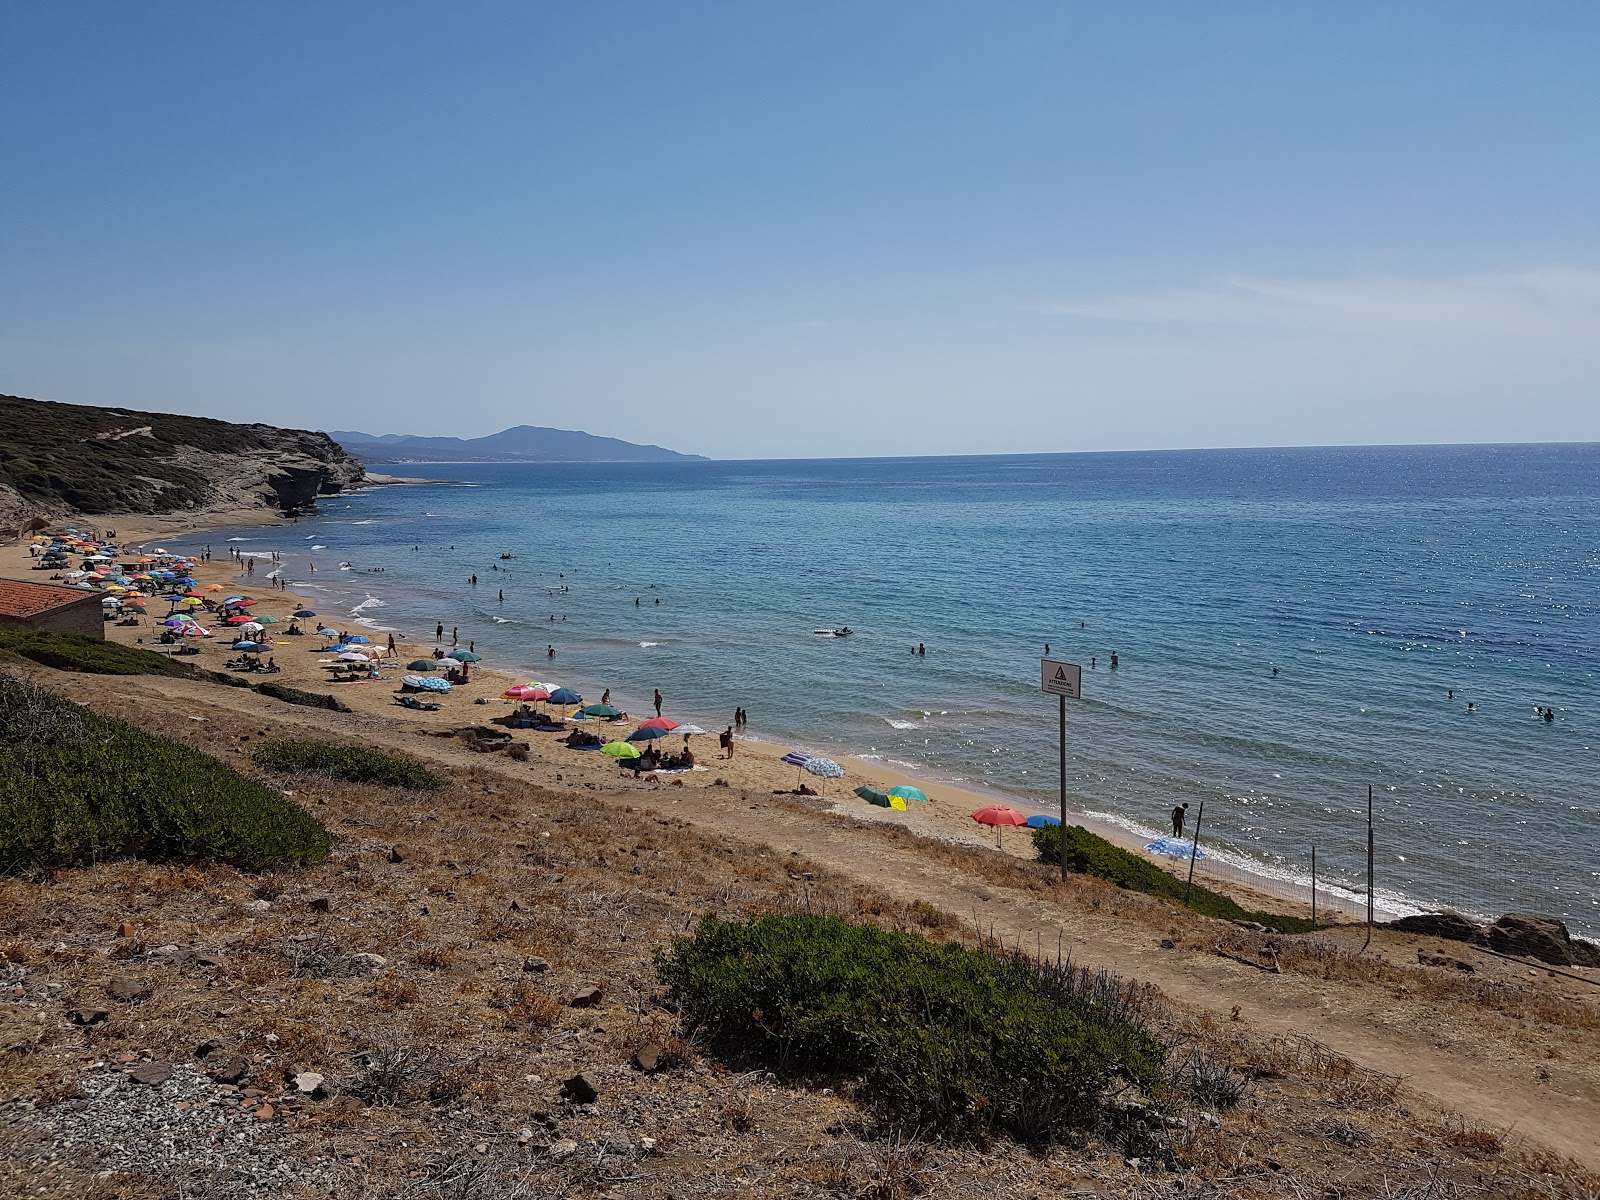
0 395 366 530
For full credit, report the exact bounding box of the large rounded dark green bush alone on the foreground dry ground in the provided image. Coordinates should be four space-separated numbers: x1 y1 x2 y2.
656 914 1163 1142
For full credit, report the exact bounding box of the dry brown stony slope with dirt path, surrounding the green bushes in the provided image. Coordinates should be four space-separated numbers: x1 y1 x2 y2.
0 669 1600 1200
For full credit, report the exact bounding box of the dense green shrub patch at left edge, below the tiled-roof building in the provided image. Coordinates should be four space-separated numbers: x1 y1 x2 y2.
0 675 333 870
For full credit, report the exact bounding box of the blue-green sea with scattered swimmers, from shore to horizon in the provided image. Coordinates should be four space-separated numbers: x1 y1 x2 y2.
184 445 1600 933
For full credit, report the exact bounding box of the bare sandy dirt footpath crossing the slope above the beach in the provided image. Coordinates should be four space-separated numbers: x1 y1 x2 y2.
12 659 1600 1170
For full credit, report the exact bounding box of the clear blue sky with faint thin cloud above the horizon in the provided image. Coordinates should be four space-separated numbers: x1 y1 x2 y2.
0 0 1600 458
